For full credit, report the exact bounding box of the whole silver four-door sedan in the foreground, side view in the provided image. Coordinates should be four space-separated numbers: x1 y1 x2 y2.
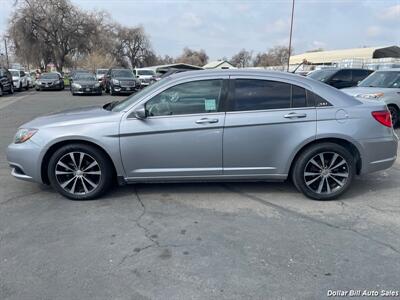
7 70 398 200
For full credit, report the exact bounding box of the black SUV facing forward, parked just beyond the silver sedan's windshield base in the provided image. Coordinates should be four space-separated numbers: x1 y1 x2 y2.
103 69 140 95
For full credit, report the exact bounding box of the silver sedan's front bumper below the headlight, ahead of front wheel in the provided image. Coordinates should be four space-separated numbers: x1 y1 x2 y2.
7 140 42 183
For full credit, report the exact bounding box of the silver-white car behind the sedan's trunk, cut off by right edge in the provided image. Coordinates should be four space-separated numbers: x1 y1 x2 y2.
343 68 400 126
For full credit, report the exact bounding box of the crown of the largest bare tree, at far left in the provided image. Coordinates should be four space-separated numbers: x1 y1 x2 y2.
8 0 103 72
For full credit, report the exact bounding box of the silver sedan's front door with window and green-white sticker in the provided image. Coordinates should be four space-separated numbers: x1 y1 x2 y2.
120 78 225 181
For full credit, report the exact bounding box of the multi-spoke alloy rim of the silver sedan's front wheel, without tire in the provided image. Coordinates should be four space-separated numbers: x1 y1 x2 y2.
55 152 102 195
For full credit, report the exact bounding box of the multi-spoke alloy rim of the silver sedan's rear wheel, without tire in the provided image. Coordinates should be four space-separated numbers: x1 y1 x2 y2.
304 152 350 195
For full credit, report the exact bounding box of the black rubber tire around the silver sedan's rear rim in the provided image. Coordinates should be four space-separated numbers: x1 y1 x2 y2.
292 143 356 200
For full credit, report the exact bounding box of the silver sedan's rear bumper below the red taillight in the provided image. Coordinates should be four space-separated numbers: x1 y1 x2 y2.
360 134 399 174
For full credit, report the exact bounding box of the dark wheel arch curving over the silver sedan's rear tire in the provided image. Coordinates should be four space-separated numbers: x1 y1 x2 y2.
288 137 362 176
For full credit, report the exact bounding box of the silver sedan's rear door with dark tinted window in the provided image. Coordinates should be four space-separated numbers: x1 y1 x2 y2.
223 77 316 179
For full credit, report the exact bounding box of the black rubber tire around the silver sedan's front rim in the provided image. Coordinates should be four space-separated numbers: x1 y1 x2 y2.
47 144 114 200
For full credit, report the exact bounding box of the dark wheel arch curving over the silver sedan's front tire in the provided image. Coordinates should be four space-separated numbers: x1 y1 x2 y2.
40 139 117 184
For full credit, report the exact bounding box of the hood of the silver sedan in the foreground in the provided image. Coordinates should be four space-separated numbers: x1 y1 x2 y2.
21 106 120 129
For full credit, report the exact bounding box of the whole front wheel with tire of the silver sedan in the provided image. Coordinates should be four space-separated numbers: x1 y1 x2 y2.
48 144 113 200
